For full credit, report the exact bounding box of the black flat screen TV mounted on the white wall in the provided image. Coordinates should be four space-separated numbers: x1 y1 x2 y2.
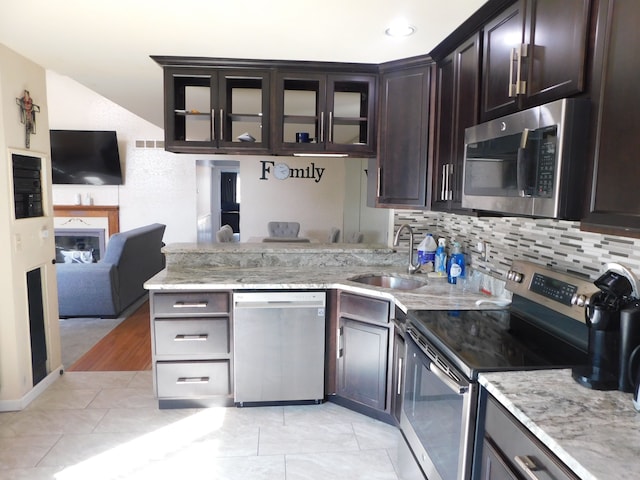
50 130 122 185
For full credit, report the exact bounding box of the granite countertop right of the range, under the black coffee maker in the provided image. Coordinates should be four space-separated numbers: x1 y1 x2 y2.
479 370 640 480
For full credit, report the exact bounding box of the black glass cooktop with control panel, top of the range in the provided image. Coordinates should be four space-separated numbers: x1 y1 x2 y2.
408 261 597 380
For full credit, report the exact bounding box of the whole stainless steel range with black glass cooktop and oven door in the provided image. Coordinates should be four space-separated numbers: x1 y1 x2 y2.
400 261 597 480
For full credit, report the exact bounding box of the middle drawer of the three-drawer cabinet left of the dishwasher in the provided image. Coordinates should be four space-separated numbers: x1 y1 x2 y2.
153 317 231 355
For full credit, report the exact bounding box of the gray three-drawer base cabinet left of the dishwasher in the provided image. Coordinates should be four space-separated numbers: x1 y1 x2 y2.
150 292 233 408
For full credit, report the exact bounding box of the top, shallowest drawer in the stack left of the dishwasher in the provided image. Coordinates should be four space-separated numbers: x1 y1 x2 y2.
152 292 231 317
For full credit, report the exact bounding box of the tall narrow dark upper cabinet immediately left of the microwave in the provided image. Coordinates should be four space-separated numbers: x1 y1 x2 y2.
431 33 480 211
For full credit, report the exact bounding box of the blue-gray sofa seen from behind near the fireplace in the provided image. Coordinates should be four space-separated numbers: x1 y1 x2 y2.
56 223 166 317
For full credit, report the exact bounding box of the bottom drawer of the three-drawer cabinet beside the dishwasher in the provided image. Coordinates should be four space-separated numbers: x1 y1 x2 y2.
156 360 231 398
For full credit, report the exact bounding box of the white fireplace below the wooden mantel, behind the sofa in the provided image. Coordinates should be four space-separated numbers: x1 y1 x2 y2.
55 228 105 263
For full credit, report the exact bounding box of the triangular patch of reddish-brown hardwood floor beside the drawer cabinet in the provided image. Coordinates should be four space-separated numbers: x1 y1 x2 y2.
67 301 151 372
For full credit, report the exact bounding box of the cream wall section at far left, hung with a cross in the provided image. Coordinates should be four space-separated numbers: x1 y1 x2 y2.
0 44 61 411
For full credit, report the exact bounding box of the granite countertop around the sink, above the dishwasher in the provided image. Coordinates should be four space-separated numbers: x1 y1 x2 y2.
144 265 496 312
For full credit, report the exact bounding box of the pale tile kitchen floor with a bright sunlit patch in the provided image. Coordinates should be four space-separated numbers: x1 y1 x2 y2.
0 372 430 480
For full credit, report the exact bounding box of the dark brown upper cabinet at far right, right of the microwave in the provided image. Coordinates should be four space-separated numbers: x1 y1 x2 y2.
581 0 640 238
